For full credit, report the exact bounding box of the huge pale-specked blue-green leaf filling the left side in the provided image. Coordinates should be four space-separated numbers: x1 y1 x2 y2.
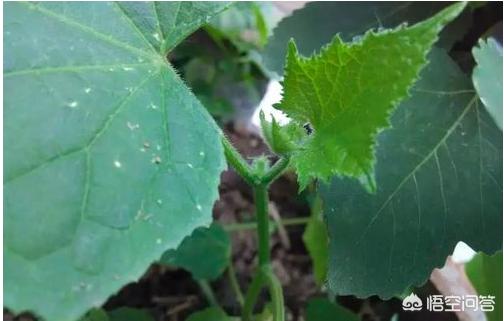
4 2 225 321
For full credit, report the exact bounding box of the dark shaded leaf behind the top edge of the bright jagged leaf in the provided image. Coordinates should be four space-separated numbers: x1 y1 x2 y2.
262 1 471 75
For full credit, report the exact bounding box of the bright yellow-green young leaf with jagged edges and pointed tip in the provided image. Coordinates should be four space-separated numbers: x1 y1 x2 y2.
275 3 465 190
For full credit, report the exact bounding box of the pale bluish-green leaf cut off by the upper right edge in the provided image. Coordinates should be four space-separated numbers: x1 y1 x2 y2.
472 38 502 129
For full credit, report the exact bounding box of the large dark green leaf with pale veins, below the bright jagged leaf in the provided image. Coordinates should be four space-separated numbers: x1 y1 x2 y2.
321 50 502 297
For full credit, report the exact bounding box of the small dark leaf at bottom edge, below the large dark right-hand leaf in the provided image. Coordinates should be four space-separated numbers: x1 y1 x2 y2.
306 298 360 321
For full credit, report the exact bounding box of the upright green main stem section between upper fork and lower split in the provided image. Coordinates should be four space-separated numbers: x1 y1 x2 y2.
254 185 270 266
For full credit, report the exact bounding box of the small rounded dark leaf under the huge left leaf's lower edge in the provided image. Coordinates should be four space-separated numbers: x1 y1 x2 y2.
161 224 231 280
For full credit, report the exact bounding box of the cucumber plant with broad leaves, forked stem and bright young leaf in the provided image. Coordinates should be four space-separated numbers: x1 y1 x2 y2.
4 2 502 321
